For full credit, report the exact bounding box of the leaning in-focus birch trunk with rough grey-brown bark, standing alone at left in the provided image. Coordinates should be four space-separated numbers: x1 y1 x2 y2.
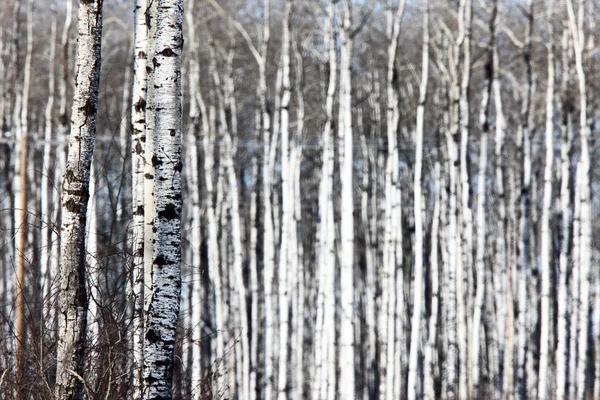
55 1 102 399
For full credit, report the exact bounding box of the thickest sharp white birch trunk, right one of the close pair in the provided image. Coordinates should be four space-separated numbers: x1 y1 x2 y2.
144 0 183 399
